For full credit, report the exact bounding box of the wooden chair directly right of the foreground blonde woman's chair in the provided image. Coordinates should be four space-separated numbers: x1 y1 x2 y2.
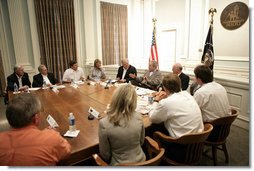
153 123 213 166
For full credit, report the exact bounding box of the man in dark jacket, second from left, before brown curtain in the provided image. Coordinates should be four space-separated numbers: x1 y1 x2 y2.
32 65 56 87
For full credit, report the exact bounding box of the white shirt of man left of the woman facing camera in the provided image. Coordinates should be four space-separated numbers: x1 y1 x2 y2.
63 67 85 81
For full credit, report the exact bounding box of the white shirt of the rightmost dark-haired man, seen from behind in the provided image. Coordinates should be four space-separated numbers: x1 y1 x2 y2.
194 81 231 122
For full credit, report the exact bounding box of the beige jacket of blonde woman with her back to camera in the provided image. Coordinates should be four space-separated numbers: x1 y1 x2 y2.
99 113 146 165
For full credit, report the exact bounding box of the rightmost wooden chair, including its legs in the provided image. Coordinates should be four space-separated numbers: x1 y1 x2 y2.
204 109 239 166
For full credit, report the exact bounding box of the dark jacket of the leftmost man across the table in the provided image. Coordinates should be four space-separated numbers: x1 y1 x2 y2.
7 72 31 91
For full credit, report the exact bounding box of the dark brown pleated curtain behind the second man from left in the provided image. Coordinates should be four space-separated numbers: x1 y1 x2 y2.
34 0 77 81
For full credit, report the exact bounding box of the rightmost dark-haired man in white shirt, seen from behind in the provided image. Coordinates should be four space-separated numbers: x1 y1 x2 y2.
194 65 231 122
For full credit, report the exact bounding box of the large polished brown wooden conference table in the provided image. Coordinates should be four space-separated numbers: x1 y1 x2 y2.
9 83 151 165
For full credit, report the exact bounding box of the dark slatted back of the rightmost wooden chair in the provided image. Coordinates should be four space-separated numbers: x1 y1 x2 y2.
207 109 239 144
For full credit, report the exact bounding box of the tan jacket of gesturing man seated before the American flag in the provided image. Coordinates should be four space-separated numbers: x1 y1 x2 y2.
136 70 162 90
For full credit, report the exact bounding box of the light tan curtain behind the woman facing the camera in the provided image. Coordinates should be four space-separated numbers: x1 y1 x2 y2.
101 2 128 65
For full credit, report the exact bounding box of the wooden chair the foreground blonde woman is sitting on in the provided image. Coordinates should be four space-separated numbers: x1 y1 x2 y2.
92 136 165 166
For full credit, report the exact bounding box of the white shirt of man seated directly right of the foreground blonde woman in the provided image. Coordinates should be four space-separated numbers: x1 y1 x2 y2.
149 91 204 138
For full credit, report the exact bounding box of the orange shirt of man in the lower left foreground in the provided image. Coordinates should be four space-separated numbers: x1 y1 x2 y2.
0 125 71 166
